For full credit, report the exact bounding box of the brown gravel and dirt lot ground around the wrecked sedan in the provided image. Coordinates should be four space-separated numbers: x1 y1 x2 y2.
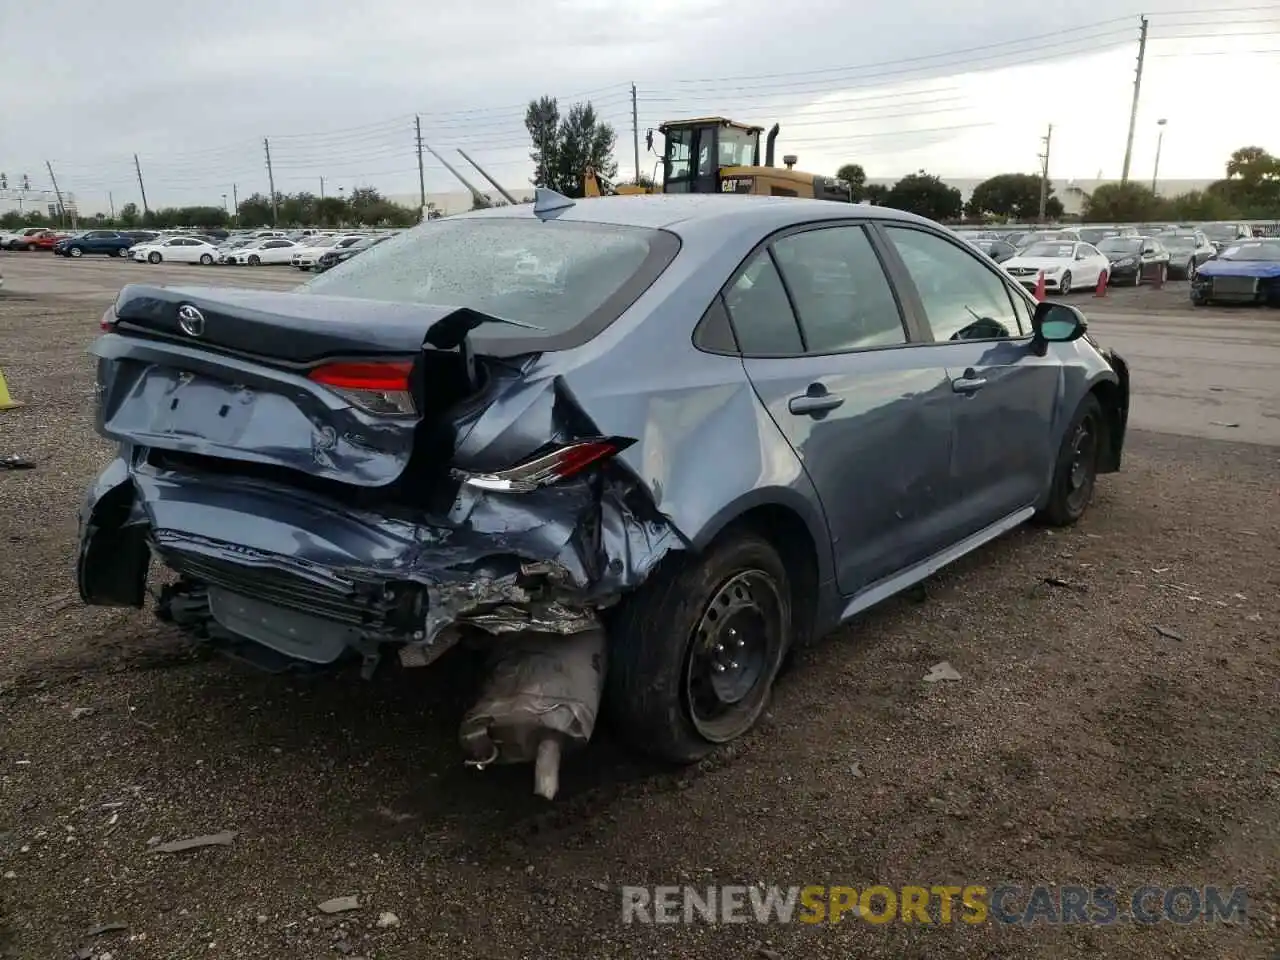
0 255 1280 960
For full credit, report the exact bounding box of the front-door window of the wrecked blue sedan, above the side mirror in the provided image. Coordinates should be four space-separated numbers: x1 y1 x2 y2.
884 227 1021 343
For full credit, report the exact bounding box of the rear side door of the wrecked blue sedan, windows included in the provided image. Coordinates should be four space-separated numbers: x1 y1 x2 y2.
723 223 952 595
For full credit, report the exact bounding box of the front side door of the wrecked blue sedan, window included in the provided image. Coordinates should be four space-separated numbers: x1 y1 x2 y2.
882 224 1061 543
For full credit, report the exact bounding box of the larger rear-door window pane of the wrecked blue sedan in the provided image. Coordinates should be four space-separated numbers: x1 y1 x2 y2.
773 227 906 353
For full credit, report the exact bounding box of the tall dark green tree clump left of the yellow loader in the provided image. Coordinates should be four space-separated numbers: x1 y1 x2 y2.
525 96 618 197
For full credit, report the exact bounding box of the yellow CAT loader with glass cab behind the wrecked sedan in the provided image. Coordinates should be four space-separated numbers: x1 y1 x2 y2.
584 116 851 204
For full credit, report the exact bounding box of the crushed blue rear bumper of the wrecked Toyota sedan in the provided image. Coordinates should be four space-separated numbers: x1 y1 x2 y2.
77 452 681 664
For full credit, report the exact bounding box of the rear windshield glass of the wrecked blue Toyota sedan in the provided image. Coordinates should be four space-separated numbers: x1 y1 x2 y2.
300 218 678 353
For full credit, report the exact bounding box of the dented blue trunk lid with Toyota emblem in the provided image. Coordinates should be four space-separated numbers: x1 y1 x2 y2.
91 285 537 498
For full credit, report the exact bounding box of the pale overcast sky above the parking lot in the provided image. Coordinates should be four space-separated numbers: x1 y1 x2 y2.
0 0 1280 212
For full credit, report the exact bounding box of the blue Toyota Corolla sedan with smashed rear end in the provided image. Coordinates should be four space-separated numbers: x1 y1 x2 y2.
78 191 1129 796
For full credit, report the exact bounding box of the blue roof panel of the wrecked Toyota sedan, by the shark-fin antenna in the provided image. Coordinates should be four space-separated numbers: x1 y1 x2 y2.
445 193 932 233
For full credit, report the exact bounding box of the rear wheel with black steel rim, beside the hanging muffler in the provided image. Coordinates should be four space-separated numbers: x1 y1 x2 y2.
605 531 791 763
